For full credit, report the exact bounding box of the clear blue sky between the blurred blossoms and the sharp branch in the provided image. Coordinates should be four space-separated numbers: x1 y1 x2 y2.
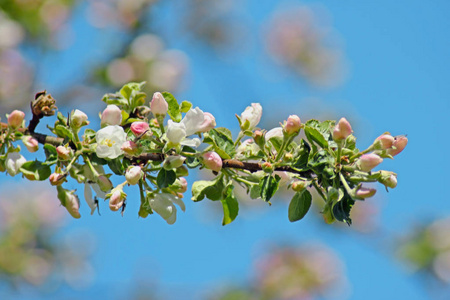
3 0 450 300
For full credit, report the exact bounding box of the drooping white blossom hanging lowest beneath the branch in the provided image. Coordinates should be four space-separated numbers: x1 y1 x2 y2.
149 193 186 225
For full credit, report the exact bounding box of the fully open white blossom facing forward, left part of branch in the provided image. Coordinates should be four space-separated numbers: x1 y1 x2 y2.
95 125 127 159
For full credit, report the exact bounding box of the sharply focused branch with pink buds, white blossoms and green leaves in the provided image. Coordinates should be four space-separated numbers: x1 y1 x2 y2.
0 83 407 225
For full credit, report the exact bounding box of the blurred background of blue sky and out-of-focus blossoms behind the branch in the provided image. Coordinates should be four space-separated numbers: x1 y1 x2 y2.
0 0 450 300
